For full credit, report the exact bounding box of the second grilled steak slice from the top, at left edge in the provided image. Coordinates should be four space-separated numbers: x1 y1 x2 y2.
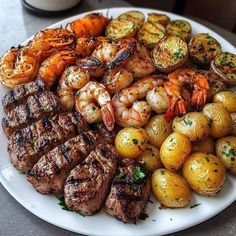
2 91 61 137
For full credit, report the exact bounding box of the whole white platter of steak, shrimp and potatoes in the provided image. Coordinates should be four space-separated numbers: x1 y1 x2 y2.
0 8 236 236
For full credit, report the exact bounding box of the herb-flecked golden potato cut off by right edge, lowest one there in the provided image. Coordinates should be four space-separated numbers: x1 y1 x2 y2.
216 136 236 175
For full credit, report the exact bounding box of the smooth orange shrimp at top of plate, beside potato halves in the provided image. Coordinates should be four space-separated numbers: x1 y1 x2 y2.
66 13 109 38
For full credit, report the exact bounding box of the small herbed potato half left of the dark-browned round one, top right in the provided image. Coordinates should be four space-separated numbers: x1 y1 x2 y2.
166 20 192 42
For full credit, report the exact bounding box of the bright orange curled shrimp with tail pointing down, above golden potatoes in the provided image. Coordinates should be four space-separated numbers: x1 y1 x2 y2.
164 68 209 121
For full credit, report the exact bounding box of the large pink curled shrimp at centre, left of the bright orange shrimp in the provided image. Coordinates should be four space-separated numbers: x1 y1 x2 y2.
112 76 163 127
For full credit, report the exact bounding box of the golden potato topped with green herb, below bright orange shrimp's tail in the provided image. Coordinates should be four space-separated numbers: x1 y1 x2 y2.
172 112 210 141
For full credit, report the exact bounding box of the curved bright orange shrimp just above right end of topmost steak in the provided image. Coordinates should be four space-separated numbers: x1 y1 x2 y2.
38 50 79 87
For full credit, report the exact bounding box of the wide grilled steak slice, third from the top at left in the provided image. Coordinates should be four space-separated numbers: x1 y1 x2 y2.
8 113 80 171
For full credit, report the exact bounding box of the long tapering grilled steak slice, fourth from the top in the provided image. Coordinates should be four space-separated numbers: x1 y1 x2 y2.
27 131 101 194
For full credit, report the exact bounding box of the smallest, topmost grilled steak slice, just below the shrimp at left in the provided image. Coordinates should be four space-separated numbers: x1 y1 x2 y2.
2 78 48 112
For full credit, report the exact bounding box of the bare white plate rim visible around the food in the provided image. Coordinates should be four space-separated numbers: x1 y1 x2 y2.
0 8 236 236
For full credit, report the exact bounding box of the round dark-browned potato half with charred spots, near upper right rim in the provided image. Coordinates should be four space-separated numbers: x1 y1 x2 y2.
188 33 221 65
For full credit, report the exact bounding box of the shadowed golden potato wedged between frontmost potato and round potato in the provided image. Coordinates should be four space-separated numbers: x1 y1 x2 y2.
138 144 163 172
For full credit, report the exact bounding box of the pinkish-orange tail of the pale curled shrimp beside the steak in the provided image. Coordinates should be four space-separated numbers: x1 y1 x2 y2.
101 102 115 131
